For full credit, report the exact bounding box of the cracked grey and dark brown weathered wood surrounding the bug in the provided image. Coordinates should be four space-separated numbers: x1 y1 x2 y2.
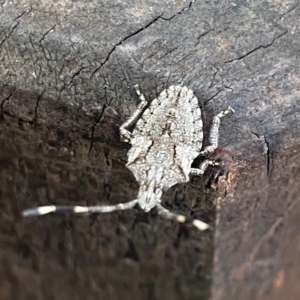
0 0 300 300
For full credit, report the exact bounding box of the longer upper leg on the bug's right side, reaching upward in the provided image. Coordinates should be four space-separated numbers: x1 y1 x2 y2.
200 106 234 155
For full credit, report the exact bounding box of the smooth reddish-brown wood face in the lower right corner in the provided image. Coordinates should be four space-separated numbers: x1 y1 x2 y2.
212 141 300 299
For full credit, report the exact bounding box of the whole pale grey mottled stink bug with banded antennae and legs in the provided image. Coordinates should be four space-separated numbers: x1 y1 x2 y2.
22 85 234 230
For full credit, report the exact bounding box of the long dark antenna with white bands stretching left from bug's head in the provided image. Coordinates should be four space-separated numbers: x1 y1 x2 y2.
22 199 138 217
